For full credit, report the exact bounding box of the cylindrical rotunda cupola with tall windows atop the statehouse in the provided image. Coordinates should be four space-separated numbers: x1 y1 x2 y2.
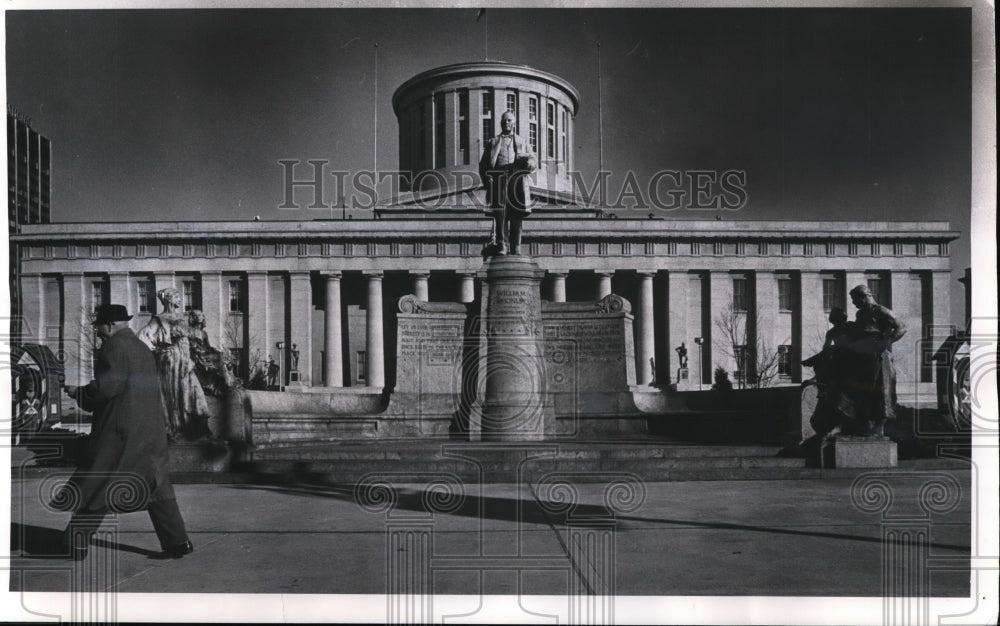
392 61 580 192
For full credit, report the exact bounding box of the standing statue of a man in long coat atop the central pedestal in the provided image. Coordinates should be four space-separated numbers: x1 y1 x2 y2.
479 111 536 255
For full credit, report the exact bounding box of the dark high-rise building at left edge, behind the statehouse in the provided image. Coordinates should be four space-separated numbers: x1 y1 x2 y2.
7 106 52 335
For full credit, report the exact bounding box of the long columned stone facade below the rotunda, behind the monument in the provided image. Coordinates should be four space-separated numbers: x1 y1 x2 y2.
12 219 956 401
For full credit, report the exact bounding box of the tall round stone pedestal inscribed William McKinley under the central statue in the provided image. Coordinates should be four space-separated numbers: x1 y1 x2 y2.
479 255 546 441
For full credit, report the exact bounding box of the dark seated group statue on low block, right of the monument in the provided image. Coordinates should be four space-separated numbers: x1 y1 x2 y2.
802 285 906 437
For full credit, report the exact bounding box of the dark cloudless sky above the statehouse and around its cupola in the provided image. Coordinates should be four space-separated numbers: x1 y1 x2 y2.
5 8 971 300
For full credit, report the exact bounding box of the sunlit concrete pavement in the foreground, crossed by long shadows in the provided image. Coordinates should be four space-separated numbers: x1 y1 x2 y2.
3 458 972 621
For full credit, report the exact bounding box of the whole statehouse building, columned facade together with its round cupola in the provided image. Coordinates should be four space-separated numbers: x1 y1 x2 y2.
11 62 958 412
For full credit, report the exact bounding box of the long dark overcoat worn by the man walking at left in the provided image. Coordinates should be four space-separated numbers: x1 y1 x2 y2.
64 328 174 513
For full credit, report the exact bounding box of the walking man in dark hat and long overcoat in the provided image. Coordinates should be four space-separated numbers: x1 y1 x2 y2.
60 304 194 560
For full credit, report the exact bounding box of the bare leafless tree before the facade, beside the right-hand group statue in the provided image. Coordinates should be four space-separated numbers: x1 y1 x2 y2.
715 300 781 389
